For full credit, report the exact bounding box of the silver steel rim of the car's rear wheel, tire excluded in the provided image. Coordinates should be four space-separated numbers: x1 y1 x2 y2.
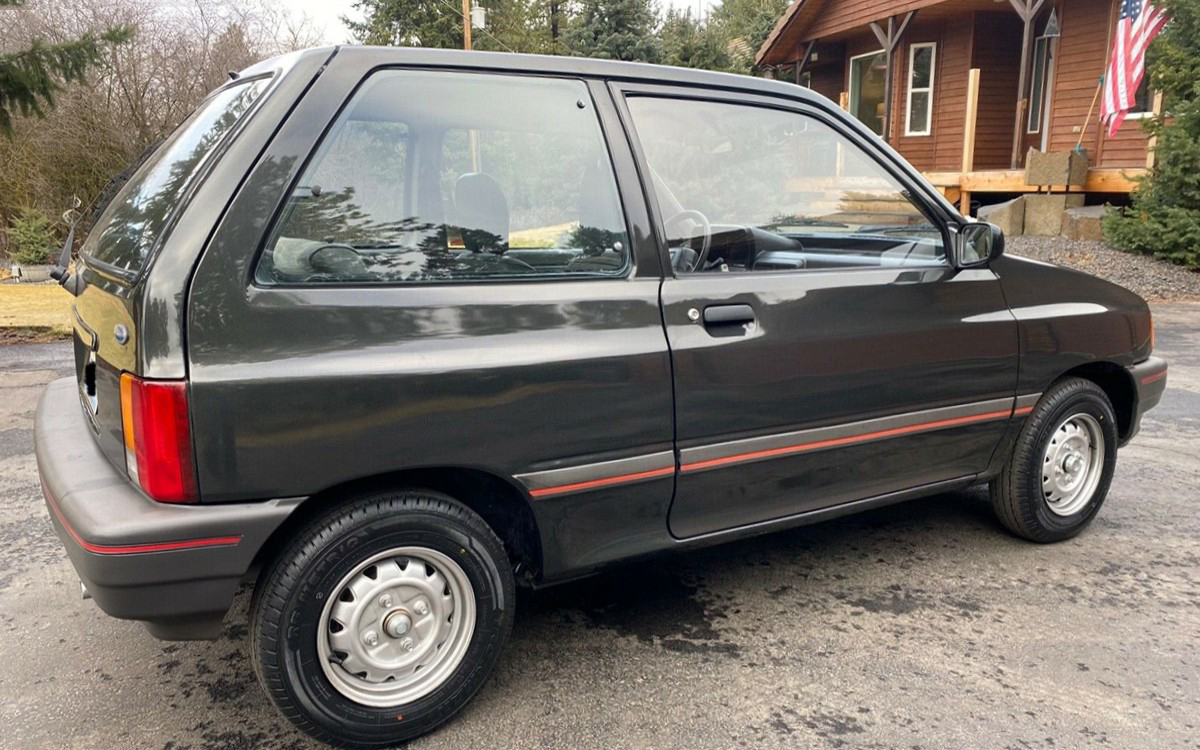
317 547 475 708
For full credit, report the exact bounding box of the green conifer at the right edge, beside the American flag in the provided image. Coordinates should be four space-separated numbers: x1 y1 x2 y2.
1104 0 1200 270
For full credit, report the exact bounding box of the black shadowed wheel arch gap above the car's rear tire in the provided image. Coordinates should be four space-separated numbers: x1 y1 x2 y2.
252 467 542 582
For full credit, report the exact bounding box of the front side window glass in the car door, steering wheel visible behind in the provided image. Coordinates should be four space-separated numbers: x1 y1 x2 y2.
628 96 946 272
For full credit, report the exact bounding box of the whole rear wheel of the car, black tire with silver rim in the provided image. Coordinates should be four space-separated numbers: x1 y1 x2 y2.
251 491 515 748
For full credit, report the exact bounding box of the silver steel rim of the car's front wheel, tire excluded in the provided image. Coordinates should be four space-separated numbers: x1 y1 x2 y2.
1042 413 1104 516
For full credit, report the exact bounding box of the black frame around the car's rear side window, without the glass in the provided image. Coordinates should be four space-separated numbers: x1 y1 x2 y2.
253 65 642 286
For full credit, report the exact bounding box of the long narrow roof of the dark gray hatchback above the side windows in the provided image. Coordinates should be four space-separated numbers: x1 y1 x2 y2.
242 44 824 102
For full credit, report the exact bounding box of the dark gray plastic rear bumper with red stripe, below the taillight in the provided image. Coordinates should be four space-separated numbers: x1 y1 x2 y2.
34 378 299 640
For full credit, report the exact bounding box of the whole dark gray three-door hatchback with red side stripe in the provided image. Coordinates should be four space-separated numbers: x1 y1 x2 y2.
36 48 1166 746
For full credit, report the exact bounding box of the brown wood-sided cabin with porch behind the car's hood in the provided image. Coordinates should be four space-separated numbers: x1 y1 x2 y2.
756 0 1162 212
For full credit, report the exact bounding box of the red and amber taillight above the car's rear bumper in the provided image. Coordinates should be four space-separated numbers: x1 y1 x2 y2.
121 373 198 503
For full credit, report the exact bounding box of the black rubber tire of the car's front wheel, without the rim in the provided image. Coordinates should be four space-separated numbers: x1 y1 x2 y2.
989 378 1117 544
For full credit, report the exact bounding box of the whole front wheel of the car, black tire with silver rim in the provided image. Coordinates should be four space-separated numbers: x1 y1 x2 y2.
990 378 1118 542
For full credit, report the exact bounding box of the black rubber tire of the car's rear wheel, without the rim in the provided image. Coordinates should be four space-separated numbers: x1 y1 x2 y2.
250 490 516 748
